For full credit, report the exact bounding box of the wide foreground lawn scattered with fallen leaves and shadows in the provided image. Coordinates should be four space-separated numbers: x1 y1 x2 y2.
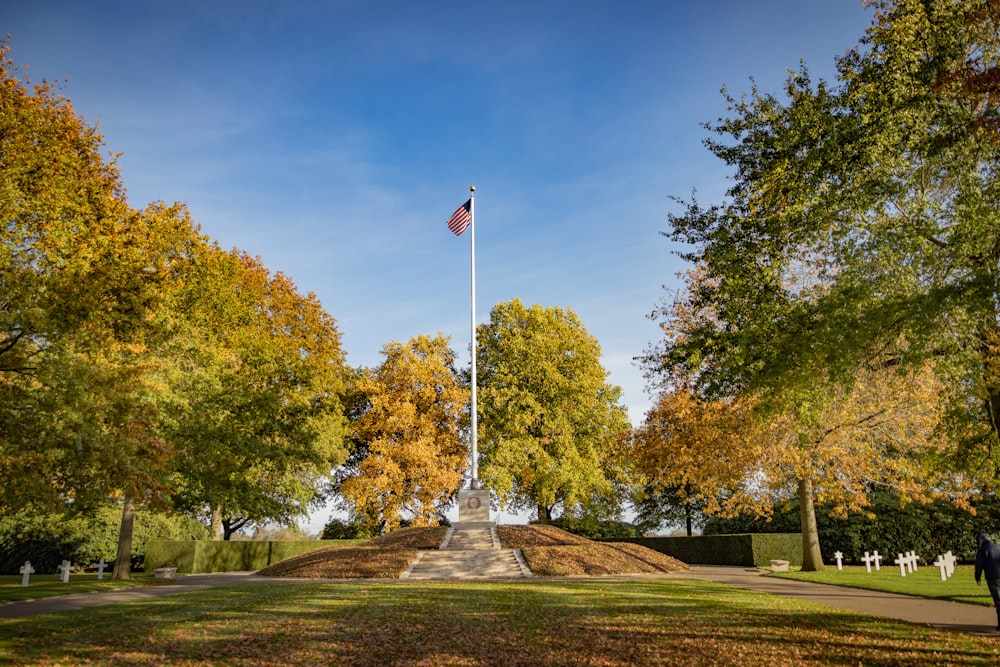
0 579 1000 667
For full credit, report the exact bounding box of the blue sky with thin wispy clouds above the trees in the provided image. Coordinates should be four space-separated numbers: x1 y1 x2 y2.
9 0 871 528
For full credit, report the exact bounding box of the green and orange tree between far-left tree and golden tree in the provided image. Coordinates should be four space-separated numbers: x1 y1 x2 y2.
164 246 346 539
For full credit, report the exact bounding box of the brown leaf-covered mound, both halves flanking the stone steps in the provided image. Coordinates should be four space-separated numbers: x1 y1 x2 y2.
260 526 688 579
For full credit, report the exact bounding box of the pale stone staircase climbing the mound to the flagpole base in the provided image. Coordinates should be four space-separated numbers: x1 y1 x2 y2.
400 522 531 579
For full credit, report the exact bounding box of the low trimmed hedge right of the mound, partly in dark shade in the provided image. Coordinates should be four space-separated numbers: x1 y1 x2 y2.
600 533 802 567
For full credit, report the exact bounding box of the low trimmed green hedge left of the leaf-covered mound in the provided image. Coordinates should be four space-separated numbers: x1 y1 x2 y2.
146 540 367 574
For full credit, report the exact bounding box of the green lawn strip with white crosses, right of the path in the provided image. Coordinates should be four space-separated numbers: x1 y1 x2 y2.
769 565 993 605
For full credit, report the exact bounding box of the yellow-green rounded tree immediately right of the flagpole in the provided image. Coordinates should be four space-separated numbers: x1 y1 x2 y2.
476 299 628 522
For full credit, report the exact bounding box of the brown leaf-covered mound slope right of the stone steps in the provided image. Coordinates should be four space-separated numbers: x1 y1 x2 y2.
497 526 688 577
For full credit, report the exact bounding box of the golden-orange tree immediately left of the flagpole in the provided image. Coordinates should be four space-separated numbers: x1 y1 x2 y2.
340 334 470 532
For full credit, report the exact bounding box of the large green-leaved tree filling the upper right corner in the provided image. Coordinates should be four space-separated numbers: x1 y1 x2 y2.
664 0 1000 485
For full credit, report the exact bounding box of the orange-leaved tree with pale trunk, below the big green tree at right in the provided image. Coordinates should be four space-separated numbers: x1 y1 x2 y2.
630 250 971 569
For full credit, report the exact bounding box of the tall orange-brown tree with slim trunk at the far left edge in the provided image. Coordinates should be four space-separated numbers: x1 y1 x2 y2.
0 46 213 578
